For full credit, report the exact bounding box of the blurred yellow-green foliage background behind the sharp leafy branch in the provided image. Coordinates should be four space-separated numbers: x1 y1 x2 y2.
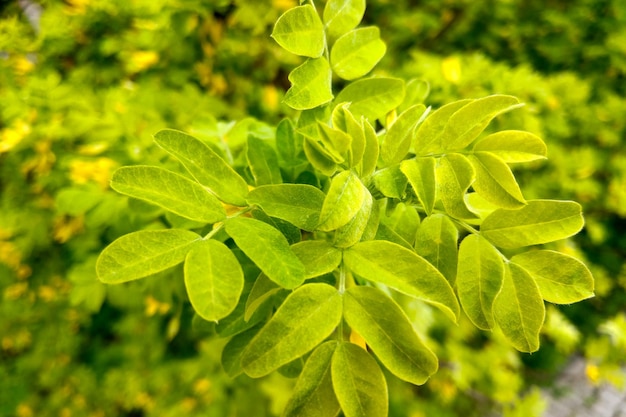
0 0 626 417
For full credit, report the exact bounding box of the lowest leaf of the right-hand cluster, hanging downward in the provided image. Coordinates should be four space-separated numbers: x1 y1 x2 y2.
493 263 545 353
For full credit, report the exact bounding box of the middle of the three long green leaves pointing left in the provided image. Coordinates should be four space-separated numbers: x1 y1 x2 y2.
111 166 226 223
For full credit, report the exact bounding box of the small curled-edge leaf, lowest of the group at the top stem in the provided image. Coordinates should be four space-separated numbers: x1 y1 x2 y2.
283 58 333 110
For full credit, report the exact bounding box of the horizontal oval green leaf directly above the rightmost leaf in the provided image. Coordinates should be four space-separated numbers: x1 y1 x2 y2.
480 200 584 249
